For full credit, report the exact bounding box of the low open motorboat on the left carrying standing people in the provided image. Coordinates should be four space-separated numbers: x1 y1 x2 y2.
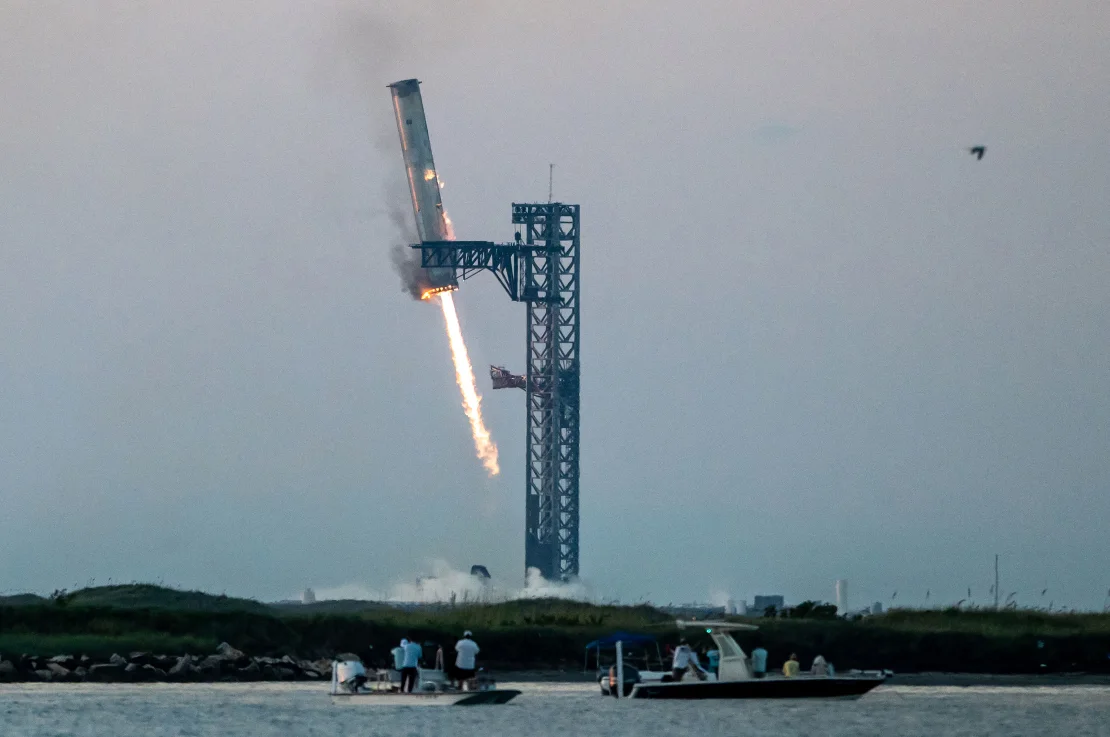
330 660 521 706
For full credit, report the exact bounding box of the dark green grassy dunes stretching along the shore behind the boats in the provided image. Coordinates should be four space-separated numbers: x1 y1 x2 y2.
0 585 1110 673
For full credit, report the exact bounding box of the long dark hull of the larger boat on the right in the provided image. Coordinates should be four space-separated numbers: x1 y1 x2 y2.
632 677 886 699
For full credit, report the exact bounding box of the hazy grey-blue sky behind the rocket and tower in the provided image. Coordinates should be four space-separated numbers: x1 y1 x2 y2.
0 0 1110 608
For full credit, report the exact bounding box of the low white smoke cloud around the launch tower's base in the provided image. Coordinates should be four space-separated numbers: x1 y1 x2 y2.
308 561 593 604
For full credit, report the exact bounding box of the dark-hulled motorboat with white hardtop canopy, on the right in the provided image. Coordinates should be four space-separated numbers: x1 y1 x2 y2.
602 620 887 699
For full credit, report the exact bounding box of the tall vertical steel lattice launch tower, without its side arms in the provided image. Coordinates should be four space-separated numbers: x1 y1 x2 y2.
513 202 581 580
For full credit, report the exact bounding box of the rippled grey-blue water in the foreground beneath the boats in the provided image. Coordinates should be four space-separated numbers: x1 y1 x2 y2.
0 684 1110 737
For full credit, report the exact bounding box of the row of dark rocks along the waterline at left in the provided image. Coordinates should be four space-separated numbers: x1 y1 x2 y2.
0 643 332 683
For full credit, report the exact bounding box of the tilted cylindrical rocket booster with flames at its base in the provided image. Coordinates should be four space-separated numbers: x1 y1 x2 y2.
390 79 458 292
